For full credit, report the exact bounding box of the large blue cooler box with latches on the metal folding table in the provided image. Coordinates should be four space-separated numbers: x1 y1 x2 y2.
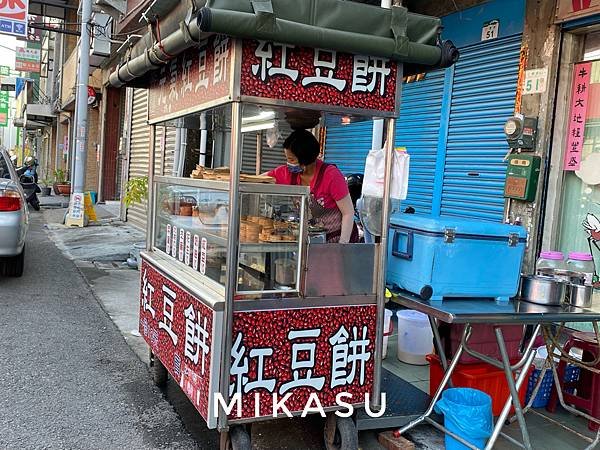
387 214 527 301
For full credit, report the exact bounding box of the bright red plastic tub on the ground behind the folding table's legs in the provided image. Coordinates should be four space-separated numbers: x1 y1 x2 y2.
427 355 533 416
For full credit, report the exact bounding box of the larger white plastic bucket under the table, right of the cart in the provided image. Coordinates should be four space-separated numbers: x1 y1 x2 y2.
396 309 433 366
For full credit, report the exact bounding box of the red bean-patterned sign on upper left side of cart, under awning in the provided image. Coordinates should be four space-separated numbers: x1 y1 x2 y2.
148 35 233 122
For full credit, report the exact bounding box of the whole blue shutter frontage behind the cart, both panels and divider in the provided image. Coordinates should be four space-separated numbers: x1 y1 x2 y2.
325 34 521 222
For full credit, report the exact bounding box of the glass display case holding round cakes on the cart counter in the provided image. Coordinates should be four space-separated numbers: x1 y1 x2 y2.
152 176 308 299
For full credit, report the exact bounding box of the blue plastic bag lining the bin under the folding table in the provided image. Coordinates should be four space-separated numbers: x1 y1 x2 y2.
435 388 494 450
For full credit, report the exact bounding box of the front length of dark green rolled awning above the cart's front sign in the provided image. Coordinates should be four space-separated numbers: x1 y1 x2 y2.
198 0 453 66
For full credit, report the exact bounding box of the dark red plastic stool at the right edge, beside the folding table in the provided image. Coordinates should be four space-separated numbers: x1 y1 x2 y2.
546 332 600 431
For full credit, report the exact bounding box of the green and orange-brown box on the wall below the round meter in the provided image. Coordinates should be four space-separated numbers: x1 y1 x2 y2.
504 153 542 202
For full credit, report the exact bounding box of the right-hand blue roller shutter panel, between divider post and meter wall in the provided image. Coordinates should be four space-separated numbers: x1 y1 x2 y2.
441 35 521 222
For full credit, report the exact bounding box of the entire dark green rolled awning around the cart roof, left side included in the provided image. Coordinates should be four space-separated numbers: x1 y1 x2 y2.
109 0 458 87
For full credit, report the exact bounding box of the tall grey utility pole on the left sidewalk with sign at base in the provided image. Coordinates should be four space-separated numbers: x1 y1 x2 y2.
66 0 92 226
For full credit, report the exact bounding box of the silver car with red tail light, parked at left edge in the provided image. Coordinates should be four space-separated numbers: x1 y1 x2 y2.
0 149 29 277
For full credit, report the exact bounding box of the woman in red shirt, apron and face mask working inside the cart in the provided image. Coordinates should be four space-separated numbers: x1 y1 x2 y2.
267 130 358 244
